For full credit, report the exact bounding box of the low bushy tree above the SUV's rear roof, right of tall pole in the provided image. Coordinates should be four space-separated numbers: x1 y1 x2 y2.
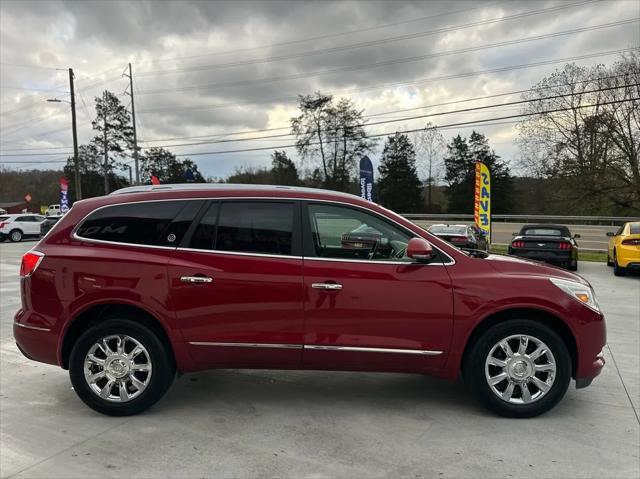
140 147 205 184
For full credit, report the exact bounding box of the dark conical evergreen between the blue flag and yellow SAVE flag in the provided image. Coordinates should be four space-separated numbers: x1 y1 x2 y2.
378 133 422 213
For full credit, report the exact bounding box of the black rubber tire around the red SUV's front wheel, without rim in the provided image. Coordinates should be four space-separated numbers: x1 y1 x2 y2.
463 319 571 418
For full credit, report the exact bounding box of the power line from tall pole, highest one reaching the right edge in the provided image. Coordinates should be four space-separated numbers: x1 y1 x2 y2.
139 18 640 95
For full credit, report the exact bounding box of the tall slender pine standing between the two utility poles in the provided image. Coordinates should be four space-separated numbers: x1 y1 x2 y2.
91 90 133 194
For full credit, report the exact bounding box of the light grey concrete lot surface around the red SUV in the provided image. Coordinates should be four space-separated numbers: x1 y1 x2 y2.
0 242 640 479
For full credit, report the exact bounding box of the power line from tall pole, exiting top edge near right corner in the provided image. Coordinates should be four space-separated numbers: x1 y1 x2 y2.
132 0 596 76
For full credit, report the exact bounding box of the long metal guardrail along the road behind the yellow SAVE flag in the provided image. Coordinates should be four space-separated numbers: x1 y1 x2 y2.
402 213 640 226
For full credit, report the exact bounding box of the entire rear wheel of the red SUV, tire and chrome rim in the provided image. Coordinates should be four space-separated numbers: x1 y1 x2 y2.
69 318 176 416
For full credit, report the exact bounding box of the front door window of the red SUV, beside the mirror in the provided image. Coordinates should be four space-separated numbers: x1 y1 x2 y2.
308 205 412 262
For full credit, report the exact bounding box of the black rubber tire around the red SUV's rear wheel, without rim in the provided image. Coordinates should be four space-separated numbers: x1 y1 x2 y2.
69 318 176 416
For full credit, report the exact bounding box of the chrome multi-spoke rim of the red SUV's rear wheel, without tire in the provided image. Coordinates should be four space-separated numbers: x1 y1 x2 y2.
84 334 152 403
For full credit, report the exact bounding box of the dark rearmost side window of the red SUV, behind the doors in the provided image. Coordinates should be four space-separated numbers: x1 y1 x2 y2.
76 201 189 245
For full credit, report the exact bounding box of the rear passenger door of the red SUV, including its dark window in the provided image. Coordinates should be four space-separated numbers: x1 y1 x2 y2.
169 200 304 368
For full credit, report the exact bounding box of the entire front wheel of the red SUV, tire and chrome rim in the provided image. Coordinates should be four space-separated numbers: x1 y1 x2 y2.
463 319 571 418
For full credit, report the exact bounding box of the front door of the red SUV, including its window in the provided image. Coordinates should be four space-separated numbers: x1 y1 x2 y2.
303 203 453 372
